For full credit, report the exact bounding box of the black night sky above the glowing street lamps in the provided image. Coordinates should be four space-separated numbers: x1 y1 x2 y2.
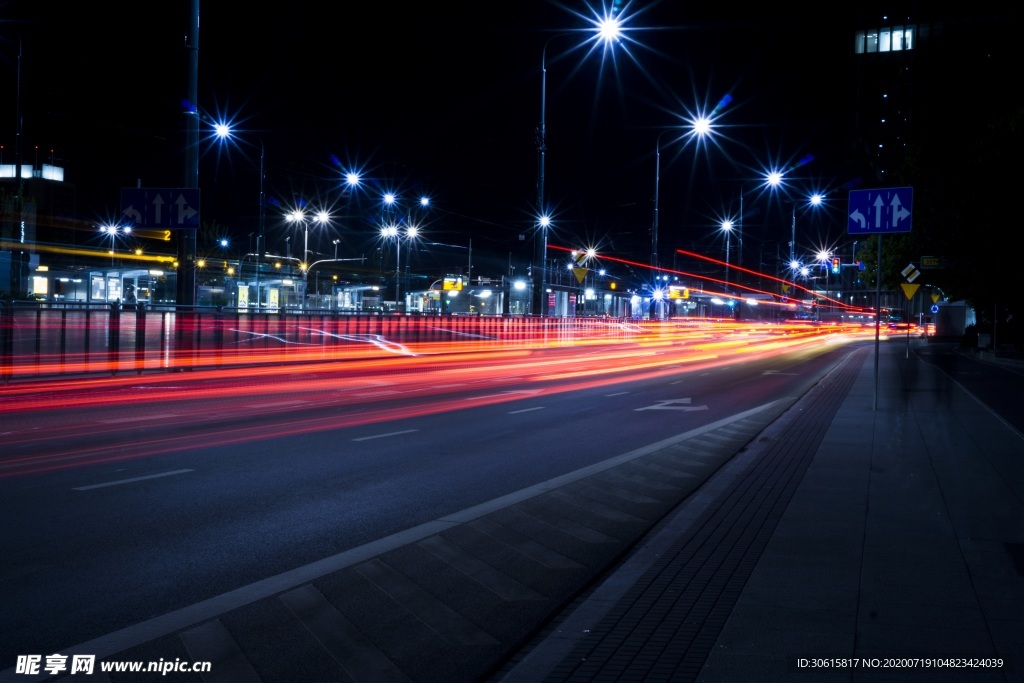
0 0 853 274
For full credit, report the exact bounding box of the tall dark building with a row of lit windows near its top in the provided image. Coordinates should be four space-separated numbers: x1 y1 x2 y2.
851 3 1003 186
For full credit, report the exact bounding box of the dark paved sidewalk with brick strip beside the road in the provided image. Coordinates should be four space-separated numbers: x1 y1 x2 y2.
495 344 1024 683
